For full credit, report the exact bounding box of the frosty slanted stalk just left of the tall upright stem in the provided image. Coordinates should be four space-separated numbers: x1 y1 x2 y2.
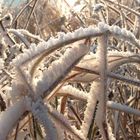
81 82 99 138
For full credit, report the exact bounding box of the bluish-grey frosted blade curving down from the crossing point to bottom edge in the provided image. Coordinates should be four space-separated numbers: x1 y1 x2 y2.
31 100 57 140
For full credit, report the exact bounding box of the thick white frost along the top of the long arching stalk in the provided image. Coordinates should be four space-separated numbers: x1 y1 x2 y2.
13 22 140 66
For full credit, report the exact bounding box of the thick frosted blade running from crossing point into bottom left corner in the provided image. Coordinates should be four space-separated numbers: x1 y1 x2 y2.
0 99 26 140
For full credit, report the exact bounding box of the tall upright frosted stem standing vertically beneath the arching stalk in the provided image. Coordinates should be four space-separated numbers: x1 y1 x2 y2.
96 34 109 140
